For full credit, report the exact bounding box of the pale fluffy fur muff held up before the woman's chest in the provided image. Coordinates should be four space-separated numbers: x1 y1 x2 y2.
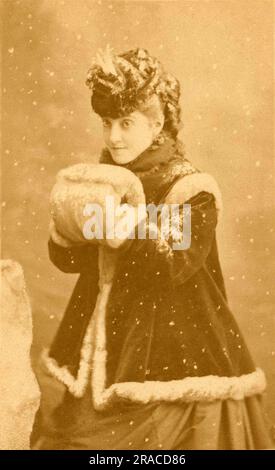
50 163 145 245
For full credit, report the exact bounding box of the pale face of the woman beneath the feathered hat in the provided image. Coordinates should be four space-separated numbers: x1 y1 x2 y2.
102 111 160 165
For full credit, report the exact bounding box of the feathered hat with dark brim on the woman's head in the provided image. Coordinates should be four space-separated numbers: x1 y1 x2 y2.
86 45 180 118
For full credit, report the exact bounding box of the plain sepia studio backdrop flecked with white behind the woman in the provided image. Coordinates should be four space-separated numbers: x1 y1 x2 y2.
1 0 275 422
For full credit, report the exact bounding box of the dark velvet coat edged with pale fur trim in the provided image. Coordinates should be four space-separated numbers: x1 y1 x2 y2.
45 138 265 410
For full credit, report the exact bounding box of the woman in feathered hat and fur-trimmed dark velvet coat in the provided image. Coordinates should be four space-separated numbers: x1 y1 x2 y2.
32 48 271 450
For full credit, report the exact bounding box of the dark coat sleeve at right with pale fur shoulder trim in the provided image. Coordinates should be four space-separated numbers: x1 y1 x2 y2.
124 174 221 286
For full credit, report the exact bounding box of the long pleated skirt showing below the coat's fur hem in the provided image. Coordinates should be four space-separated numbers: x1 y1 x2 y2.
31 366 274 450
